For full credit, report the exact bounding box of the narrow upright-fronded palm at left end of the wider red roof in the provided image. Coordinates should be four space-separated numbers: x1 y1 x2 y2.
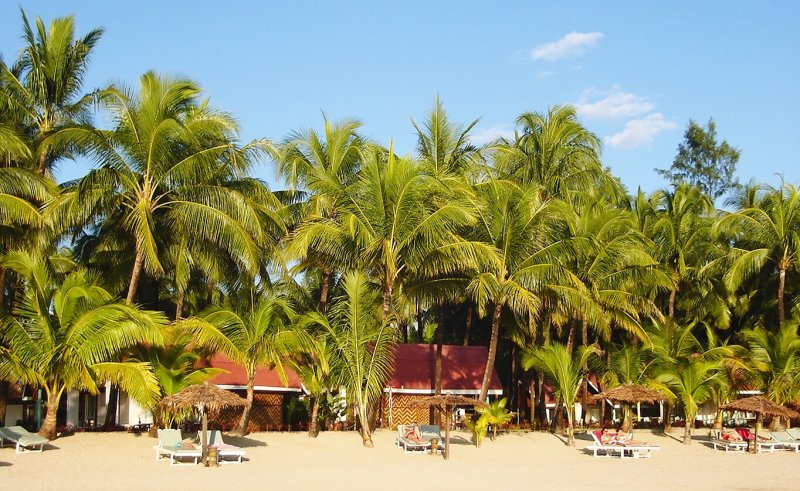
319 272 398 447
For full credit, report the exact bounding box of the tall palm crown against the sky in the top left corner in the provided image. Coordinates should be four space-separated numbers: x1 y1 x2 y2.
0 9 103 175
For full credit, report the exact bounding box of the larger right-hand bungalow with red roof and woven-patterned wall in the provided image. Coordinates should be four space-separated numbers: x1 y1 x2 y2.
380 344 503 427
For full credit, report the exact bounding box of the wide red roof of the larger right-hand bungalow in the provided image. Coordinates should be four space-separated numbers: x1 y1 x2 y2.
386 344 503 394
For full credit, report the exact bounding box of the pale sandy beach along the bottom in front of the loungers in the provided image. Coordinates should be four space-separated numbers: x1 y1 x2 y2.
0 430 800 491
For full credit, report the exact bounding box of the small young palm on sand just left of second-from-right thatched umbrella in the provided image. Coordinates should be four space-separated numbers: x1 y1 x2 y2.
522 343 599 447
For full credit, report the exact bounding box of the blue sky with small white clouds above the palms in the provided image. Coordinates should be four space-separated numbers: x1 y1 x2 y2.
0 0 800 192
